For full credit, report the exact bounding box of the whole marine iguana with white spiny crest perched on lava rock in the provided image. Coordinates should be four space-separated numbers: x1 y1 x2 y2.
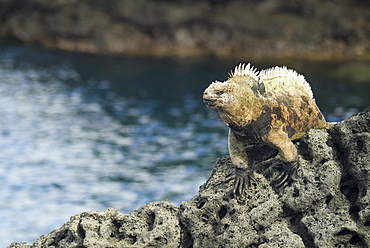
203 64 329 195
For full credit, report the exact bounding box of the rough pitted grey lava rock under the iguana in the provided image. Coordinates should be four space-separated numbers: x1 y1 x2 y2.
9 107 370 248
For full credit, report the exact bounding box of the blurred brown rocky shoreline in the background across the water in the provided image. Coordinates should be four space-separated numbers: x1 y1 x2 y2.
0 0 370 60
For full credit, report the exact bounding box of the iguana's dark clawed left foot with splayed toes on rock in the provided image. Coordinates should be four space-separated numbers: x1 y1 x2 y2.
225 167 256 196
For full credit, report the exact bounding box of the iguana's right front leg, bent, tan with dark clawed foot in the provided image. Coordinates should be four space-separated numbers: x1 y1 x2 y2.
264 130 298 188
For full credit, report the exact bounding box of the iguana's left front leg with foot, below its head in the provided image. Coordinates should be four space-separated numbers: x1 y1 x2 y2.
228 129 256 195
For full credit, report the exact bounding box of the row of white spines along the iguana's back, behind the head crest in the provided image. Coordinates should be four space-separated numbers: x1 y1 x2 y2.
259 66 313 98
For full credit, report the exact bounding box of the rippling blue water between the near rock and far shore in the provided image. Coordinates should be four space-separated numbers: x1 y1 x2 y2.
0 40 370 247
